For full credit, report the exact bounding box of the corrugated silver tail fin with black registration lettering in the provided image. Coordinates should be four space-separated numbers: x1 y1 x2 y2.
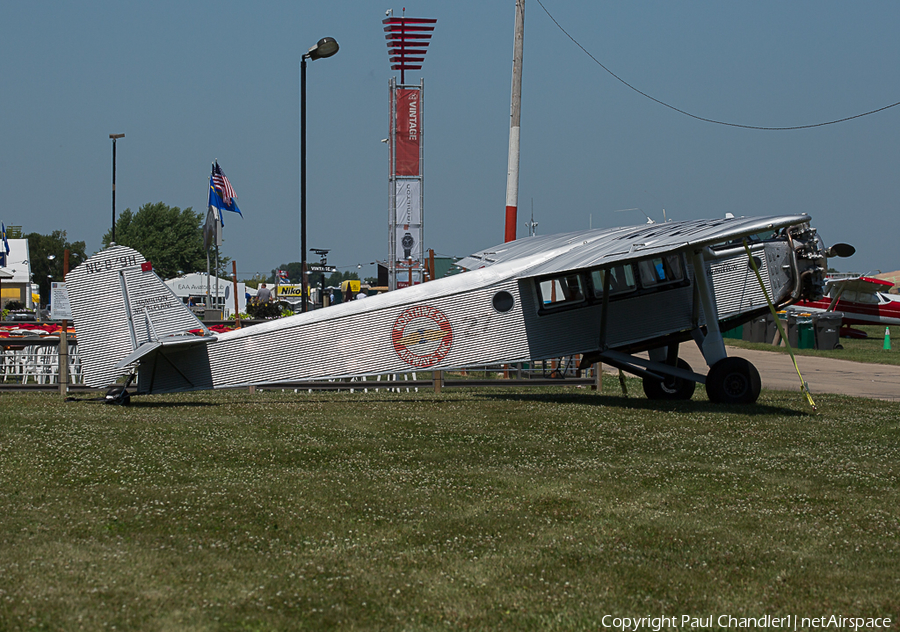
66 246 209 388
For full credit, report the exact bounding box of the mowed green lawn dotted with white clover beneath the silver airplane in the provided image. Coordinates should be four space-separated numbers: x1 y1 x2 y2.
0 378 900 630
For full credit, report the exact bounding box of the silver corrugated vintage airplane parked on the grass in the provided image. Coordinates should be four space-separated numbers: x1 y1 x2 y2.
66 215 852 403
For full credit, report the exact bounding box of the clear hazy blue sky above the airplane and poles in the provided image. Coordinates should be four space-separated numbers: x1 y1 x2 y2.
0 0 900 278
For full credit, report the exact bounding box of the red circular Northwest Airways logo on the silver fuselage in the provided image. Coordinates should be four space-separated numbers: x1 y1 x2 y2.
391 305 453 369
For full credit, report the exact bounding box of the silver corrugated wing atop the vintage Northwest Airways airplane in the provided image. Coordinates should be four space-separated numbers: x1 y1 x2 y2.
456 214 809 277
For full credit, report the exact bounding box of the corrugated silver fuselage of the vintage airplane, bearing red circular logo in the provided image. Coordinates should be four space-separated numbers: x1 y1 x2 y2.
132 242 789 393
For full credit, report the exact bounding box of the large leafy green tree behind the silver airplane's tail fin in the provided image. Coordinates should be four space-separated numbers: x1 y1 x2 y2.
103 202 230 279
